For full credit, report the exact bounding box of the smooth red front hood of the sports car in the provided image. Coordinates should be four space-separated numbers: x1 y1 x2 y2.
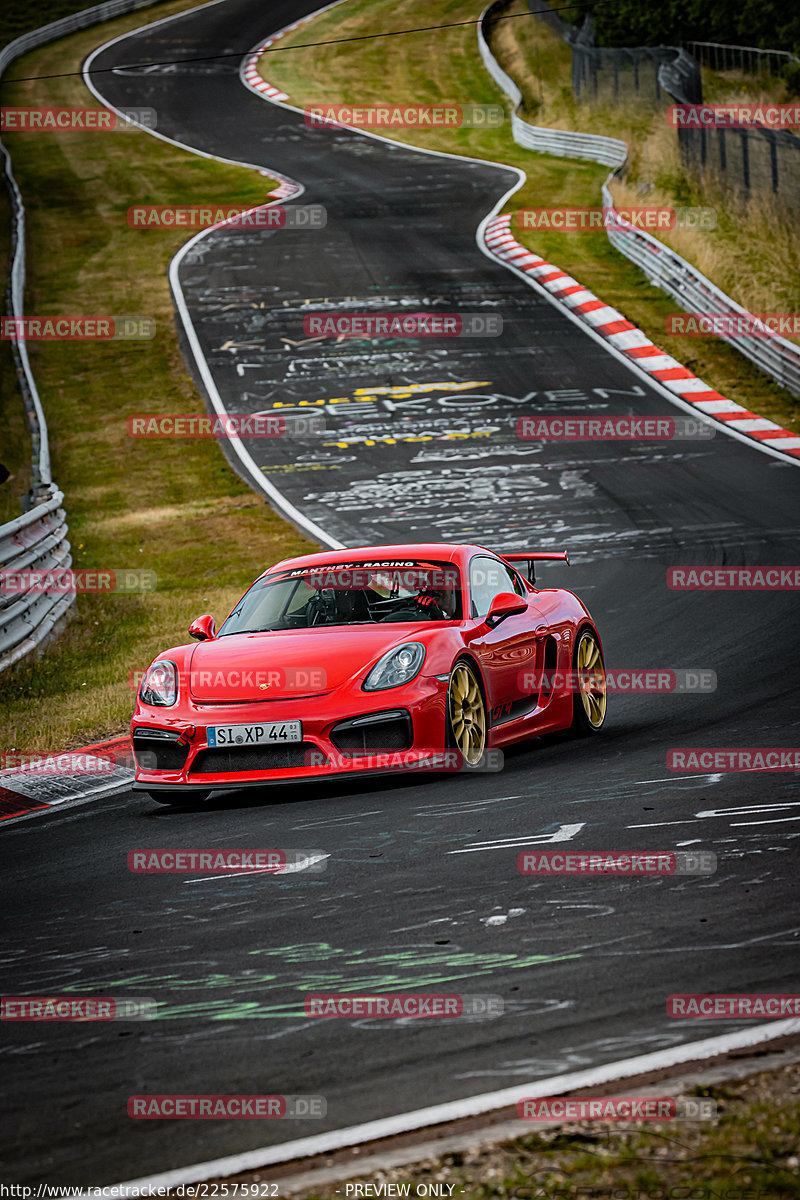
188 625 429 704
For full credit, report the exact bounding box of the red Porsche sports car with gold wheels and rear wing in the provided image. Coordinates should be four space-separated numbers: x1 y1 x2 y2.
131 542 606 804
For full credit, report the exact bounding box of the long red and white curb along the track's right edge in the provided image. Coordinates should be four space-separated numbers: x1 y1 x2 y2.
485 212 800 458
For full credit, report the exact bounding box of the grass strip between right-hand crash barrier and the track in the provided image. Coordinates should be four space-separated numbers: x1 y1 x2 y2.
259 0 800 431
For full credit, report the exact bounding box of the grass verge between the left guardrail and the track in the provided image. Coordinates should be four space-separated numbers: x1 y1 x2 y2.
0 0 317 752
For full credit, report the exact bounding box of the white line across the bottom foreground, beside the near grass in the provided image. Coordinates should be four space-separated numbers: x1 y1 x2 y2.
95 1018 800 1200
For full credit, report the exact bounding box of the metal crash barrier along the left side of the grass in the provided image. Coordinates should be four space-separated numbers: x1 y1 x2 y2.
0 0 164 671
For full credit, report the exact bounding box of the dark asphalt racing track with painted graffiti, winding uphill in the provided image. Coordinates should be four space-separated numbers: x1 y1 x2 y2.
0 0 800 1184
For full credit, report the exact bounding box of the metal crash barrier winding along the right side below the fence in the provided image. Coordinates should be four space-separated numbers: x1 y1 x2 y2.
477 0 800 396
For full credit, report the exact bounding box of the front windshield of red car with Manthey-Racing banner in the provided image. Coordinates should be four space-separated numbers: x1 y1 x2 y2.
218 560 462 637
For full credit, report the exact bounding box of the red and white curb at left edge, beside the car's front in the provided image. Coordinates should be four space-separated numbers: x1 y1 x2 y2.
0 734 133 823
